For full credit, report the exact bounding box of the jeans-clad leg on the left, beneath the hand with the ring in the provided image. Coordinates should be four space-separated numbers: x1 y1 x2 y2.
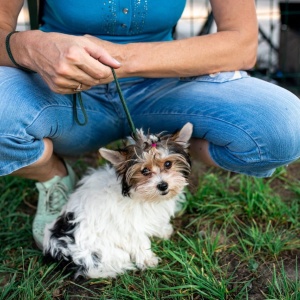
0 67 122 175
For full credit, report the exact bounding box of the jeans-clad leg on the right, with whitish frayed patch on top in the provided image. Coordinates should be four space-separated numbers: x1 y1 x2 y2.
128 72 300 176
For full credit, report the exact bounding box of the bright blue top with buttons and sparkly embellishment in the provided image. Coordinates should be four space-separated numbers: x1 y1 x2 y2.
41 0 186 43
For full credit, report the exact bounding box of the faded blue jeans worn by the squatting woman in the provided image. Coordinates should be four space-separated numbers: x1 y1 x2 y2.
0 67 300 177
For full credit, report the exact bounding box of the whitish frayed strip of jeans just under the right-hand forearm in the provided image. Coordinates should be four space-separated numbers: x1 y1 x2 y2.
180 71 249 83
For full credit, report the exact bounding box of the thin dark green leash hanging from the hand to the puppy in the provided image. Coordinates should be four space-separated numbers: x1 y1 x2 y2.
73 68 136 135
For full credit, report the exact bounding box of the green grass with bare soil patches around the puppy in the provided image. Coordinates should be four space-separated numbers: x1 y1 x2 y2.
0 161 300 300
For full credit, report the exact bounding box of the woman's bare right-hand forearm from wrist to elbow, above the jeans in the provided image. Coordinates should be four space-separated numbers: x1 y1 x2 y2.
120 31 257 77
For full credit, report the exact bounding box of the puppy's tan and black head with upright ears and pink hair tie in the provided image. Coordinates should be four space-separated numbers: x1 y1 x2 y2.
99 123 193 201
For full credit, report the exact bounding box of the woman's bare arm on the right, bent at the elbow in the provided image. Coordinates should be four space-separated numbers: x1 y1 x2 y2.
95 0 258 77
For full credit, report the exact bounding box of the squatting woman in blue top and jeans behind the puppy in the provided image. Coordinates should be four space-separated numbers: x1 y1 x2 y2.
0 0 300 247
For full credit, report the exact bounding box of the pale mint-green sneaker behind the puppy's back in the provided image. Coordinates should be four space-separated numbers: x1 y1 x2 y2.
32 164 76 250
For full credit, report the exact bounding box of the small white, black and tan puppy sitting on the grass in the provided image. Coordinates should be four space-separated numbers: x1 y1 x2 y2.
43 123 193 278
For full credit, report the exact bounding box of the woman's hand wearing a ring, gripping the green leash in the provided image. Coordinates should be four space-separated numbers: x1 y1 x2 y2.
11 30 120 94
